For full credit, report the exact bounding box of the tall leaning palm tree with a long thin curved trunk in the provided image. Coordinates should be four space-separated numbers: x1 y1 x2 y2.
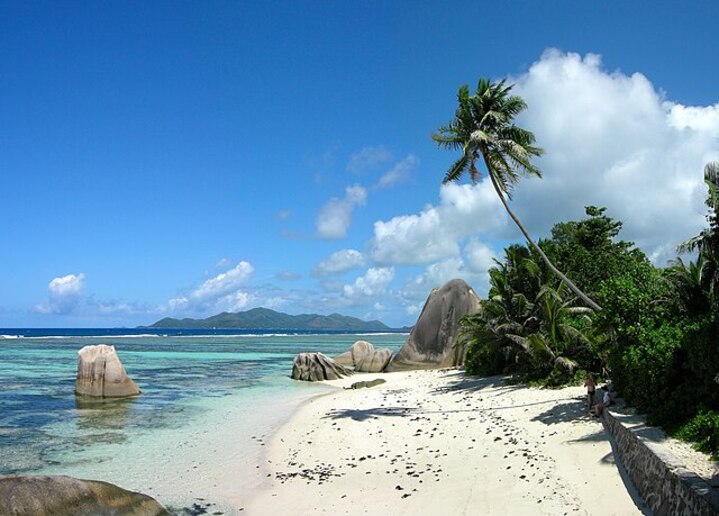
432 78 601 310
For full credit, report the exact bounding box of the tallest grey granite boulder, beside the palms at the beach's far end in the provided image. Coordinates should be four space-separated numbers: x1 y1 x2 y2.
385 279 480 371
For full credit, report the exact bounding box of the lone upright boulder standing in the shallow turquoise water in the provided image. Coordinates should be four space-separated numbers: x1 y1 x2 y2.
75 344 140 398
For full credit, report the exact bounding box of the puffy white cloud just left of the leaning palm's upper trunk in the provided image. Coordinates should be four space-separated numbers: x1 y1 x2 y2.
370 181 506 265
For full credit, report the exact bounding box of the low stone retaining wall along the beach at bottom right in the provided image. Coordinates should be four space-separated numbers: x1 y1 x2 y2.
604 411 719 516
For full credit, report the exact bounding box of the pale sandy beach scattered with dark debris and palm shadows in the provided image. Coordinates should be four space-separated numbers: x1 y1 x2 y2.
248 370 645 515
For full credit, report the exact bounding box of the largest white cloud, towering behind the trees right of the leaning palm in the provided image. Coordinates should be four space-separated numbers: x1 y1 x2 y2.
513 50 719 265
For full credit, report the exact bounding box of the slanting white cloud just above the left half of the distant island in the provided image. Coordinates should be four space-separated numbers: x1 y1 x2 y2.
168 261 254 312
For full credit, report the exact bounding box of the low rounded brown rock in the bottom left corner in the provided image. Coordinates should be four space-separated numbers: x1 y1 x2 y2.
0 475 170 516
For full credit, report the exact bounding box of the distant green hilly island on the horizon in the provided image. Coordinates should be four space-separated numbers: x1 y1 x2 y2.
147 308 391 331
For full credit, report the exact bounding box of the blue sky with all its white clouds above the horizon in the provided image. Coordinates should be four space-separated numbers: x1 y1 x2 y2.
0 1 719 327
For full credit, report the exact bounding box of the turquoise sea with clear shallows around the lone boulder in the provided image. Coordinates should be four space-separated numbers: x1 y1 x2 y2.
0 329 406 506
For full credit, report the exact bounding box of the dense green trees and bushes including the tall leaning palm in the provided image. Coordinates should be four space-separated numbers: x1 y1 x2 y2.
433 79 719 455
